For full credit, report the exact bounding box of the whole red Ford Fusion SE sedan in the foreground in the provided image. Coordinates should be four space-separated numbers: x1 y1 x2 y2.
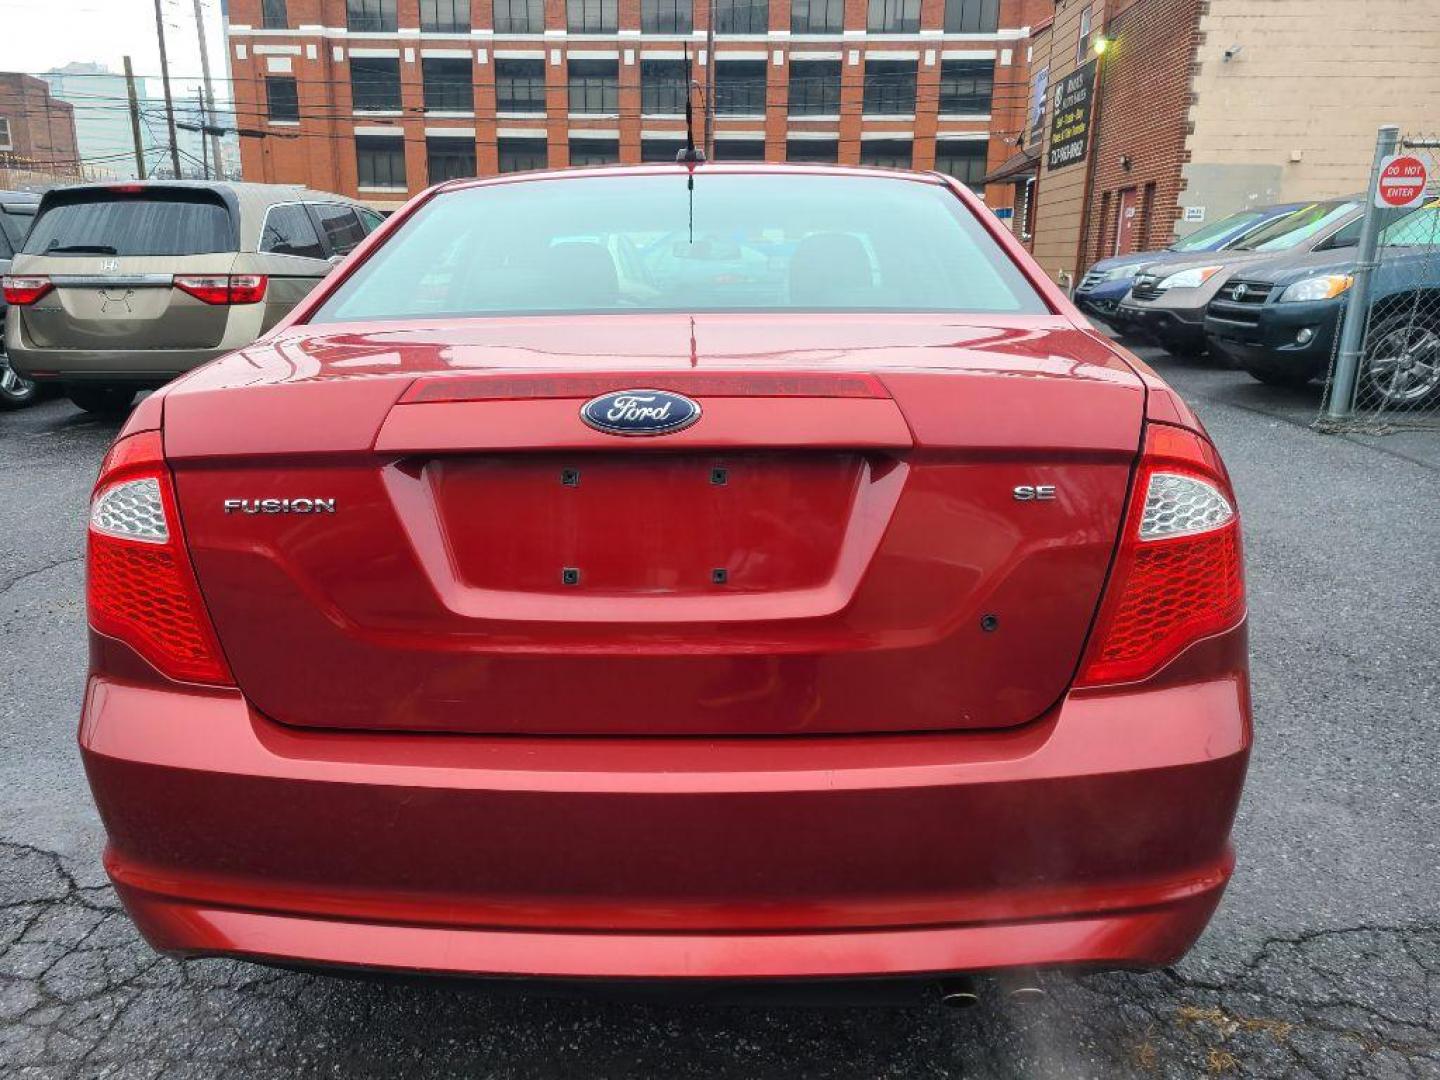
79 164 1250 996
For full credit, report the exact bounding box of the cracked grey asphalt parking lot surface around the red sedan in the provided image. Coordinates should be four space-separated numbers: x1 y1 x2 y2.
0 350 1440 1080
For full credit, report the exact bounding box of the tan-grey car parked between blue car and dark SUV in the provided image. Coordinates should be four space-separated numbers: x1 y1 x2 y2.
1120 199 1361 356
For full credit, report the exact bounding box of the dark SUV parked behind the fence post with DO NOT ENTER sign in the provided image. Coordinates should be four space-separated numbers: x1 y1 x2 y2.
1205 199 1440 408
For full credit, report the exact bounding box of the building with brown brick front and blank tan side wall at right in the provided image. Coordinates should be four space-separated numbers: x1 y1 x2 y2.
1019 0 1440 285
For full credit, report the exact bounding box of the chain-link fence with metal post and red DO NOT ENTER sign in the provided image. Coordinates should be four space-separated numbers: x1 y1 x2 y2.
1315 128 1440 435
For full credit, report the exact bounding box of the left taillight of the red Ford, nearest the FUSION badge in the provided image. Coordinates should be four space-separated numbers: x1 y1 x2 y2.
86 432 235 685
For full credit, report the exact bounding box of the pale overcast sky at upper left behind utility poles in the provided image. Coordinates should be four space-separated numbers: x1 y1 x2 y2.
0 0 230 101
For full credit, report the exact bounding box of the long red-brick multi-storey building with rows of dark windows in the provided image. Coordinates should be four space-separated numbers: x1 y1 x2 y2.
228 0 1051 209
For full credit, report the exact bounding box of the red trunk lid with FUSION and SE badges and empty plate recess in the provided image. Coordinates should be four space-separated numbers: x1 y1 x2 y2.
166 317 1143 736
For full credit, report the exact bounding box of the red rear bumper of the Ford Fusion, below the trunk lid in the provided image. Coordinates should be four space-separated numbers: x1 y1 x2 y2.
81 626 1250 979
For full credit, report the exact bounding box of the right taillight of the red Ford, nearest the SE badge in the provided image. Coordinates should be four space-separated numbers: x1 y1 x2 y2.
1077 423 1246 685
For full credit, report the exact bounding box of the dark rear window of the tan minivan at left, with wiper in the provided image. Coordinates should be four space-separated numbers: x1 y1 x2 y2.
24 192 236 256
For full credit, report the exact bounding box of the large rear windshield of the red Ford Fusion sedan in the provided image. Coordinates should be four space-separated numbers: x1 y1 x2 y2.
311 168 1047 323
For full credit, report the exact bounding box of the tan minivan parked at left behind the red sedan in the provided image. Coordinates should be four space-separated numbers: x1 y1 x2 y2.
4 181 380 412
